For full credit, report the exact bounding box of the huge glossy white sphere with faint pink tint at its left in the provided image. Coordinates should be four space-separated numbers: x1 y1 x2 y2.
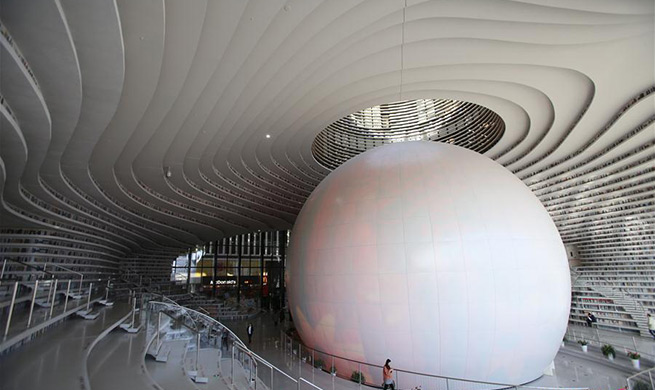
288 142 570 383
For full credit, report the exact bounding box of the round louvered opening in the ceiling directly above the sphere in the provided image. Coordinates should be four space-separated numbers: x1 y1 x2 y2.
312 99 505 169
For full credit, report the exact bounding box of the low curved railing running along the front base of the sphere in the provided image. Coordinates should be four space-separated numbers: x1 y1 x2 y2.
280 331 588 390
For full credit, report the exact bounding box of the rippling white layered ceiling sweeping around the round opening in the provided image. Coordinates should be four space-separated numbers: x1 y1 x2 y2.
0 0 655 272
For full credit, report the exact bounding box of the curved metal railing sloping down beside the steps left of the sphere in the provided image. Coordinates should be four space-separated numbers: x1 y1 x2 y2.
142 293 322 390
